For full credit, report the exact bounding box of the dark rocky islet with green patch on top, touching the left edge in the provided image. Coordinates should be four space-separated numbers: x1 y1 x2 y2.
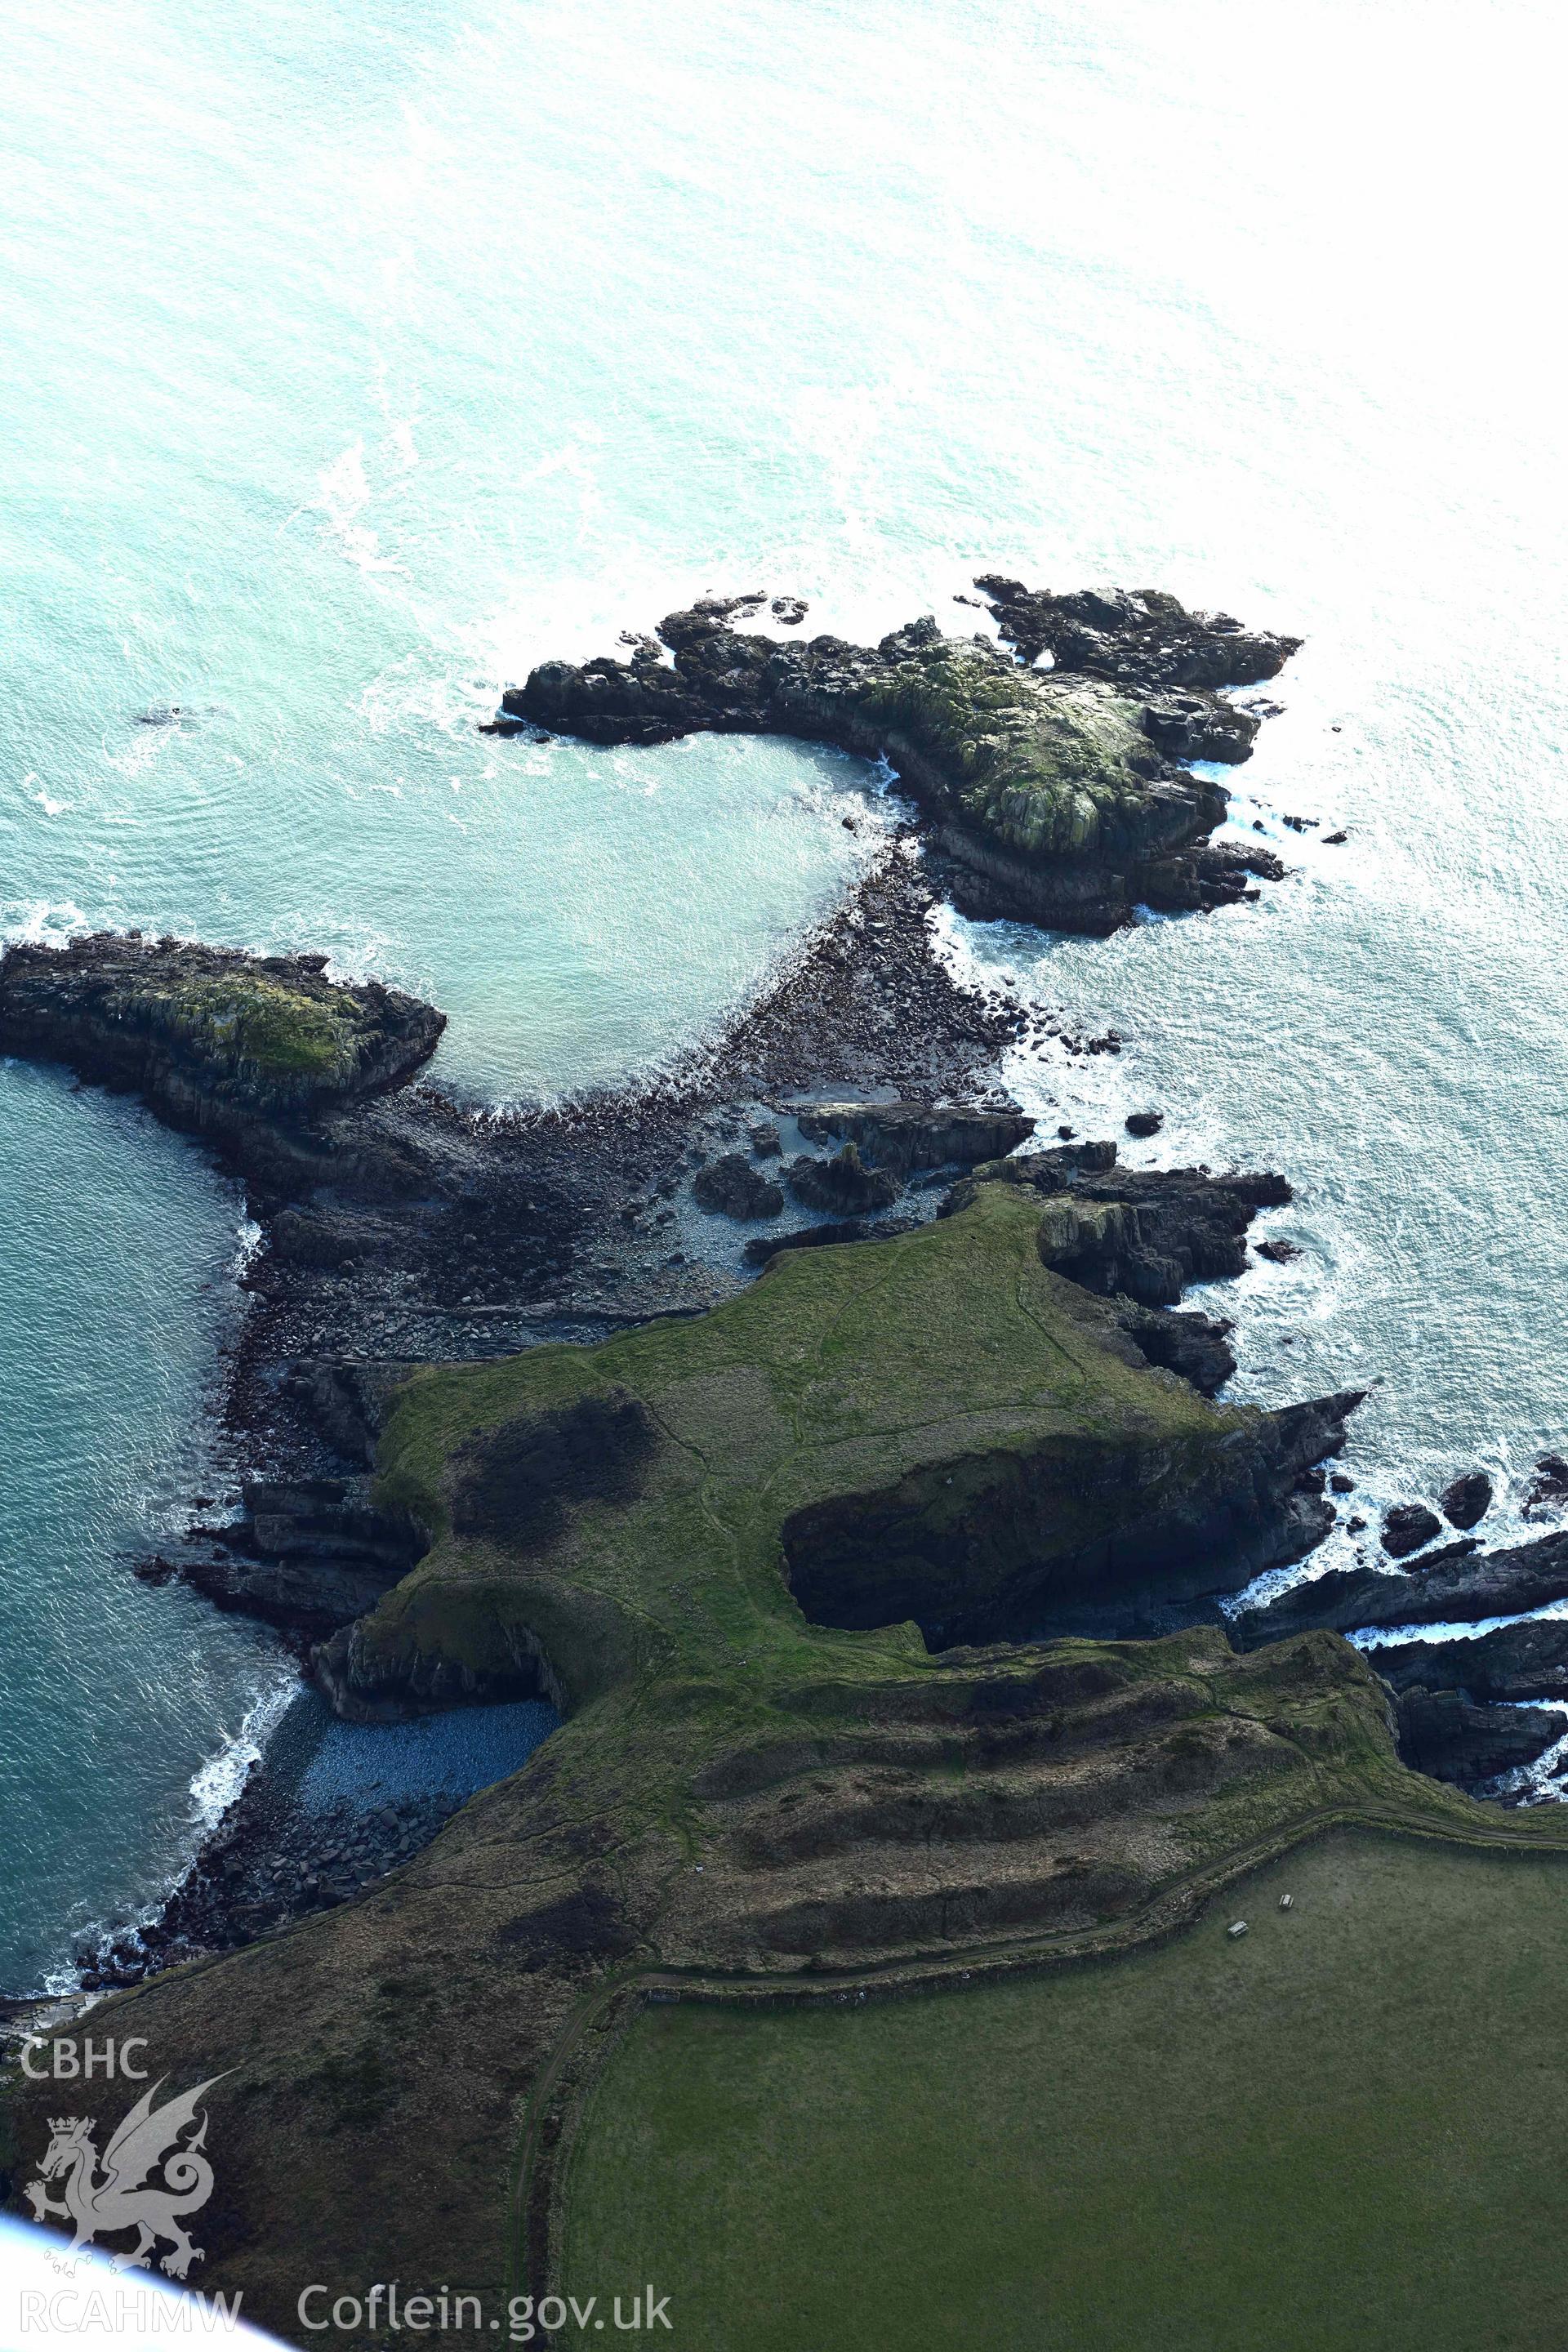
0 931 447 1176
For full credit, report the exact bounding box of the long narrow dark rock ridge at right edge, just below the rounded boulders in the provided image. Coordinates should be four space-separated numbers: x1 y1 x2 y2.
1232 1536 1568 1649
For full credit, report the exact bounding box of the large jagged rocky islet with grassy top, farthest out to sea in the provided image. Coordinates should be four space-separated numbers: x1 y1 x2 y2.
501 577 1300 931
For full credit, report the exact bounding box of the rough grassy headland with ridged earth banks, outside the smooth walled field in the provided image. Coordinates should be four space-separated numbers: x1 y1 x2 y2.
12 1187 1563 2323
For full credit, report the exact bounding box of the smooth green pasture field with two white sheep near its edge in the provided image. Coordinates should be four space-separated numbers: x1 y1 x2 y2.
559 1833 1568 2352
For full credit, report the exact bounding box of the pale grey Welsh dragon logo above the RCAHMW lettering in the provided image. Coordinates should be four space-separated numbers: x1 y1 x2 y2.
26 2074 223 2279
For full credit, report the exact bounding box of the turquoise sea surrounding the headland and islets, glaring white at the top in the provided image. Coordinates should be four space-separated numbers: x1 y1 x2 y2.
0 0 1568 1983
